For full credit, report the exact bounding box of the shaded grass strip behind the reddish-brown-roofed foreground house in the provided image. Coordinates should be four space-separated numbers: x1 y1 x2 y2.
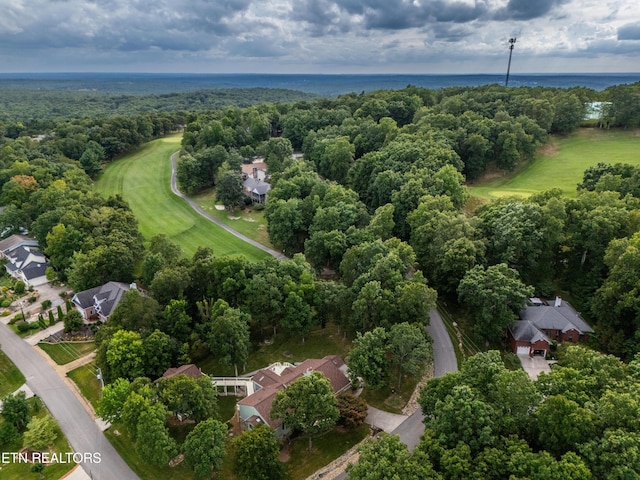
196 324 350 377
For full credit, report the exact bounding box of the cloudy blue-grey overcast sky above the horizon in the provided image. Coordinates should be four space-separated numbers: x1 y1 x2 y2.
0 0 640 74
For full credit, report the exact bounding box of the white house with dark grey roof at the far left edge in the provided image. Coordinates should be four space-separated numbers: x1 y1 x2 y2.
0 235 48 287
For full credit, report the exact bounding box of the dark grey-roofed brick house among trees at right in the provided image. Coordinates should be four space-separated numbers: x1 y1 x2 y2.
509 297 593 356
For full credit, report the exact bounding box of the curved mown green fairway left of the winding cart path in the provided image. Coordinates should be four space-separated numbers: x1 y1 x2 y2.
95 135 268 261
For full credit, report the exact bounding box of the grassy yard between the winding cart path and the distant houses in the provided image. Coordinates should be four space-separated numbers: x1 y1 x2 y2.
192 189 273 248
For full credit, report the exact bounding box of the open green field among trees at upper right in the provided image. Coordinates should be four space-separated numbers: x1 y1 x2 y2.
469 128 640 199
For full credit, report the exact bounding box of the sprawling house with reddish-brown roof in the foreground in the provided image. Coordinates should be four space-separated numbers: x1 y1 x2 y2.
236 355 351 438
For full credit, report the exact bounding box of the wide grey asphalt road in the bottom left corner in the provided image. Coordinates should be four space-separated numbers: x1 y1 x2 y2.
0 323 138 480
